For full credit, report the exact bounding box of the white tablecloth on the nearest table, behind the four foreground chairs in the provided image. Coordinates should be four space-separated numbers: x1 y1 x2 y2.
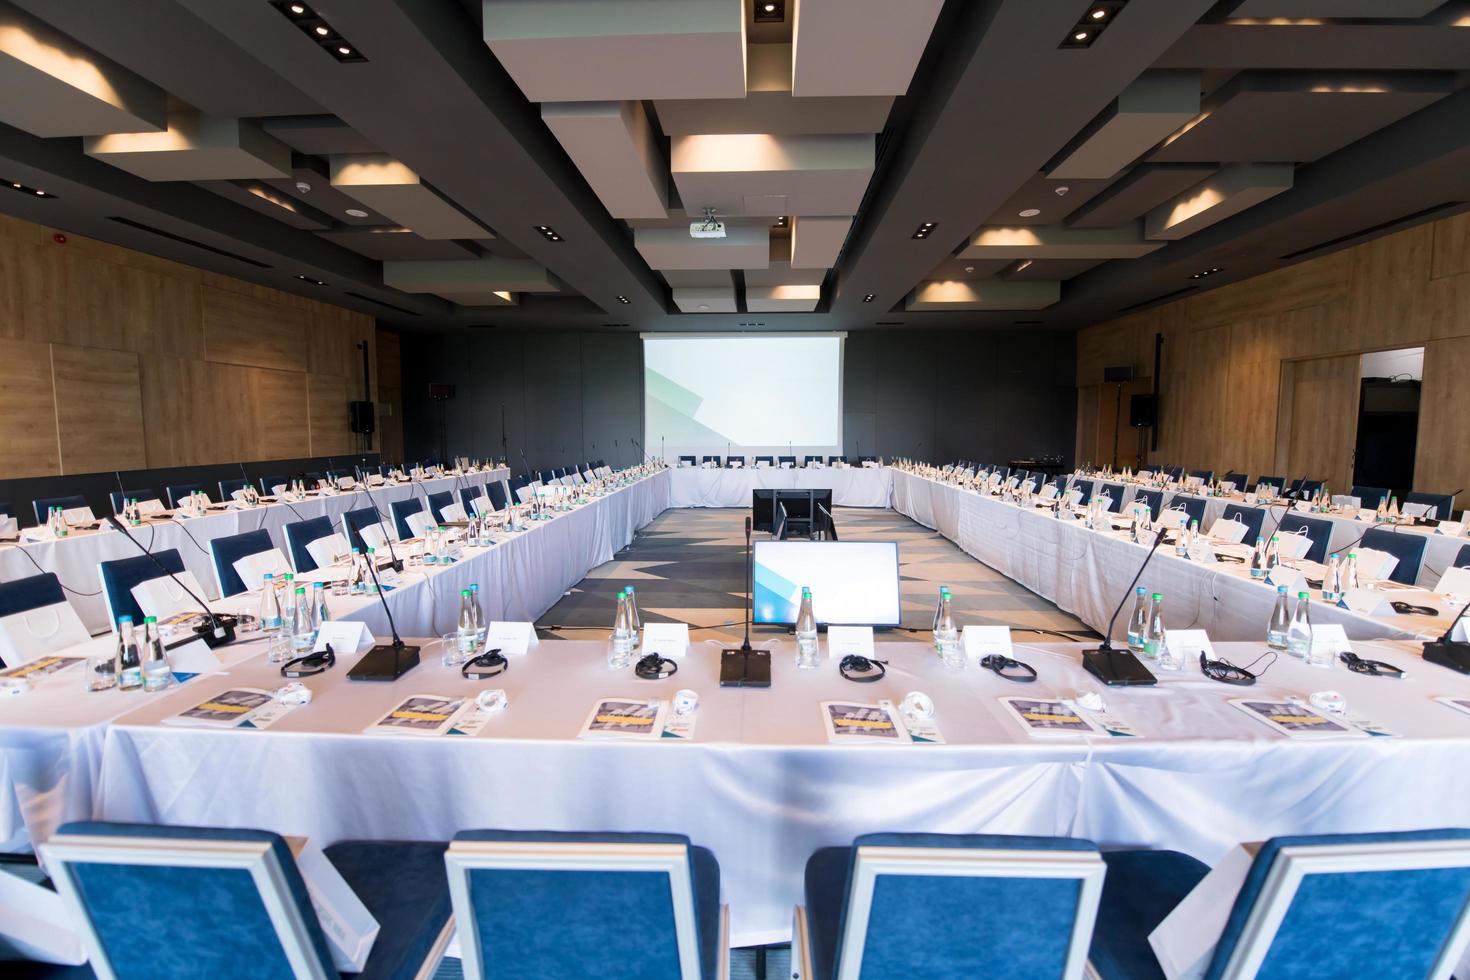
97 631 1470 945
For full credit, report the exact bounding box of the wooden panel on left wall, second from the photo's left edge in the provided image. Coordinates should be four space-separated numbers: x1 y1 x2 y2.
51 344 148 473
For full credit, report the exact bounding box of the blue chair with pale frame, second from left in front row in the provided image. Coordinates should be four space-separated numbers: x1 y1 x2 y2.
444 830 729 980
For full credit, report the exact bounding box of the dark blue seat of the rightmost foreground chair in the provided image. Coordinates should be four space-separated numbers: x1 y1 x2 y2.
1088 851 1210 980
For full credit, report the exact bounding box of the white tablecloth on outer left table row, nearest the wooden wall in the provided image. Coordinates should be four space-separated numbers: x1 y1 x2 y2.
0 467 510 633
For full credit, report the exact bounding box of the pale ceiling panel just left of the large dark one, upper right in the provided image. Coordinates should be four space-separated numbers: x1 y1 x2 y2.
1048 72 1200 179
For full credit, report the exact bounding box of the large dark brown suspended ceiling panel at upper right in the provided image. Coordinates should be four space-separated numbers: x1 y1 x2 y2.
1148 70 1454 163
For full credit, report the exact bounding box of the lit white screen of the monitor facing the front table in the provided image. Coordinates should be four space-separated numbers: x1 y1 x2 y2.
751 541 903 626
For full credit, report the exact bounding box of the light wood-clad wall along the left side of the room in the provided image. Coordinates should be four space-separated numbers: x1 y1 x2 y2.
0 216 376 478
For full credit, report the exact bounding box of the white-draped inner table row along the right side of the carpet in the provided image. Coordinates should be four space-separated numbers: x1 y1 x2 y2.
892 469 1458 641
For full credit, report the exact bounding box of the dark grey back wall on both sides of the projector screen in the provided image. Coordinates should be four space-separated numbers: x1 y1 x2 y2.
403 331 1076 470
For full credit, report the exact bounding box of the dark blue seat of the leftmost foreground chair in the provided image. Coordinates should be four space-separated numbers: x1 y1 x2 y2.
325 840 451 980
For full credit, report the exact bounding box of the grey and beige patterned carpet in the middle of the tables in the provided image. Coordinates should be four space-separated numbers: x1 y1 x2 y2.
538 507 1095 642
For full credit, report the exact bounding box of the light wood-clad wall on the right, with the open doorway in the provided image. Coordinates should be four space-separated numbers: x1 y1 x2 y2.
1078 215 1470 492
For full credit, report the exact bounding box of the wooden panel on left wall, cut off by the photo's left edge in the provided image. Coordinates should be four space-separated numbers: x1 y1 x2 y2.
0 339 62 481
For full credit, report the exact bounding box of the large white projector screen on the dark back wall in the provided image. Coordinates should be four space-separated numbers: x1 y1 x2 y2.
642 332 847 464
